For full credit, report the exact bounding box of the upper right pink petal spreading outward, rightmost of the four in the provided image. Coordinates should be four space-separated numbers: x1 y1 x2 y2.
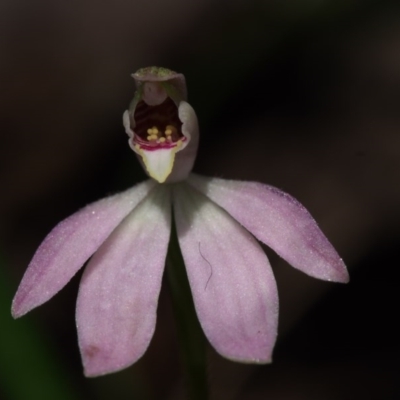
189 174 349 283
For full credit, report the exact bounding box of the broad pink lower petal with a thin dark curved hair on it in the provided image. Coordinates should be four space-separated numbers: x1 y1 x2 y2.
173 184 278 363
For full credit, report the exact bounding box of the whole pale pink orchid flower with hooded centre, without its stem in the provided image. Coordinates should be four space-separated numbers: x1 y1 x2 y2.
12 67 348 376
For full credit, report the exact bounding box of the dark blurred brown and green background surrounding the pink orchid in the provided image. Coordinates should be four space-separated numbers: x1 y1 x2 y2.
0 0 400 400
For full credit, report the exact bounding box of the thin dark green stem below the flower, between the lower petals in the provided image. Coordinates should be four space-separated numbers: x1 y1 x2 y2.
167 217 208 400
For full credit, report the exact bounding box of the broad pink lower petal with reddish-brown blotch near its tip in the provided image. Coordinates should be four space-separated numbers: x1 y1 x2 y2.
76 186 171 376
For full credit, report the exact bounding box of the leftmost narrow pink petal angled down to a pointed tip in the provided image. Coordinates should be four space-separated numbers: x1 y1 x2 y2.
12 181 154 318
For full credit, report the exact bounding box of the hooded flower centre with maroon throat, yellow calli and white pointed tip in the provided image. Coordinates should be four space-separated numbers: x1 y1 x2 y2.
123 67 199 183
